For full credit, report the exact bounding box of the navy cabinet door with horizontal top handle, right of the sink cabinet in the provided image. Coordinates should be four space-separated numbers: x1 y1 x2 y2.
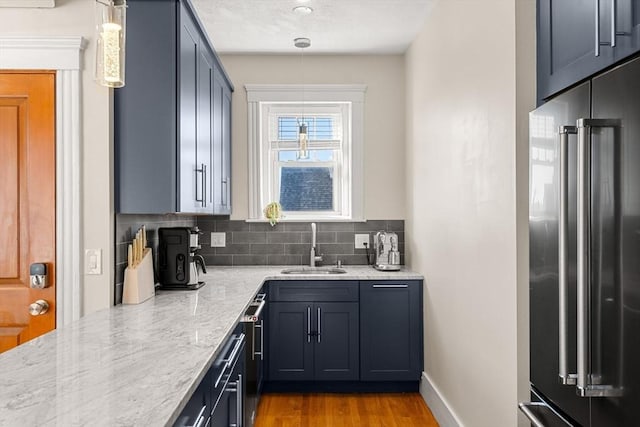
360 281 423 381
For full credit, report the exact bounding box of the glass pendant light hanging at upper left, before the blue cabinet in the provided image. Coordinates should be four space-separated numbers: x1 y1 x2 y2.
95 0 127 87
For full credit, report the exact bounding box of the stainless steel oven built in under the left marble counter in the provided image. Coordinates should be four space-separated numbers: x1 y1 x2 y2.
242 293 267 427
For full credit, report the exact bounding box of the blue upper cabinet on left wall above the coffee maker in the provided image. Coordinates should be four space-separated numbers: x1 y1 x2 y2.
114 0 232 214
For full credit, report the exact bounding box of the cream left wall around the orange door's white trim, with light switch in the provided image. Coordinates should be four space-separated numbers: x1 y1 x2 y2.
0 0 114 314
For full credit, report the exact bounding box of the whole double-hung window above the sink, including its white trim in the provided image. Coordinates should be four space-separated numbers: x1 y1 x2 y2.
247 87 363 221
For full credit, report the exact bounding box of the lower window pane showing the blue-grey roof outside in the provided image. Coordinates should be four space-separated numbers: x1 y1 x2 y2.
280 167 333 211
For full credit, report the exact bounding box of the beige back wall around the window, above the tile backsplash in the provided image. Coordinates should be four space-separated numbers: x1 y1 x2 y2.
215 54 405 219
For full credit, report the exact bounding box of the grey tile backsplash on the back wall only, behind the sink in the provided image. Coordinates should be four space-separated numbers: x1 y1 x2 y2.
196 221 404 265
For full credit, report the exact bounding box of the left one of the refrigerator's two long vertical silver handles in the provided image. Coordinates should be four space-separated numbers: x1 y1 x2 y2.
556 126 578 386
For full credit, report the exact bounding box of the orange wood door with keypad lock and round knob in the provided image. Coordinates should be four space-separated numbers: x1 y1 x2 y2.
0 71 56 352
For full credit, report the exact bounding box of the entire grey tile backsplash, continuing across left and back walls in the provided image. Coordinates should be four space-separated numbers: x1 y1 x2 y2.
115 214 404 304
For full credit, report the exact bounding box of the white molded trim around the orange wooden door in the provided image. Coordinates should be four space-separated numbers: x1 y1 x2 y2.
0 36 85 326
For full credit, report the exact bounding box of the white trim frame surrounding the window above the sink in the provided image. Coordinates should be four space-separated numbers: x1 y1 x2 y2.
245 84 367 221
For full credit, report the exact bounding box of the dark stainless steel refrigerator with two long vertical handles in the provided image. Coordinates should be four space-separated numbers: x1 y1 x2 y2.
520 55 640 427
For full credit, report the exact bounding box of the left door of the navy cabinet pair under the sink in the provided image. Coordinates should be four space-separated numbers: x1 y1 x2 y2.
268 302 315 381
